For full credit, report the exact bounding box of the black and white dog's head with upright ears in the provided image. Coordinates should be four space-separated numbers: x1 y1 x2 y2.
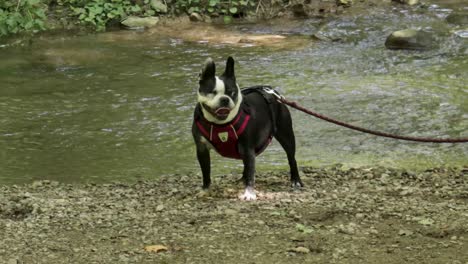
198 57 242 124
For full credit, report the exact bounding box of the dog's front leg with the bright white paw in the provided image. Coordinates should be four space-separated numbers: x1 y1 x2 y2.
239 147 257 201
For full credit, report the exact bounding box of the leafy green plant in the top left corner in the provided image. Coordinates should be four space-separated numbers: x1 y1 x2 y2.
0 0 47 36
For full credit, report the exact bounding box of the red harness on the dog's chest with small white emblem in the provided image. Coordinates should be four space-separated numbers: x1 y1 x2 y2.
195 107 272 159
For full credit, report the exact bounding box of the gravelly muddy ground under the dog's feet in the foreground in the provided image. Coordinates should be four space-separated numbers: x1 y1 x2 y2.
0 167 468 264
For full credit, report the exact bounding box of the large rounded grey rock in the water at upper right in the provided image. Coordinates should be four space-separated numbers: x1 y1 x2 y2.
385 29 434 50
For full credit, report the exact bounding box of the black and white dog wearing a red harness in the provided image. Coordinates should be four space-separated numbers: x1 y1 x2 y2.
192 57 303 200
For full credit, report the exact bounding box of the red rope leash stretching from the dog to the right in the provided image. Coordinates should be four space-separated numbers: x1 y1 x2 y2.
278 96 468 143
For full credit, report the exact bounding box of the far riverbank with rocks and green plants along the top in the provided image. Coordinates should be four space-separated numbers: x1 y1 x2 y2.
0 0 426 39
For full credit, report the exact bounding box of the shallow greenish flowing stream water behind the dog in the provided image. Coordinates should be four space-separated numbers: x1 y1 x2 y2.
0 2 468 183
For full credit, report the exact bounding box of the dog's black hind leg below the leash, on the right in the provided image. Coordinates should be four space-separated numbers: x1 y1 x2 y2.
273 105 304 188
